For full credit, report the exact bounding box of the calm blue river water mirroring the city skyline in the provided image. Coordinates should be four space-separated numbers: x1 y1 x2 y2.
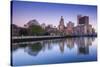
11 37 97 66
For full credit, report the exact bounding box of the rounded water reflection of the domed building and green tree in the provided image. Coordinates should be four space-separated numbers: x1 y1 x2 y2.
25 43 42 56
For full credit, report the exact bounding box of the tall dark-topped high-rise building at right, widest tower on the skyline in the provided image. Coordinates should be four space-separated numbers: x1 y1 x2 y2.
77 15 92 35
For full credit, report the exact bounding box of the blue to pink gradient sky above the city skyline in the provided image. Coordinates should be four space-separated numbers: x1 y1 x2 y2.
11 1 97 29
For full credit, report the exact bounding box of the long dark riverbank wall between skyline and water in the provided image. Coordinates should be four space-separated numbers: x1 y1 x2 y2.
11 35 97 43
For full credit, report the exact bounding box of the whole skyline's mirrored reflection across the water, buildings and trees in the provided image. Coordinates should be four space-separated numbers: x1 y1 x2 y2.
12 38 95 56
